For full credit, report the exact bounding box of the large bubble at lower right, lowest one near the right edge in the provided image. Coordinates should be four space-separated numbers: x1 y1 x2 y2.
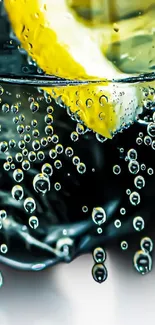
133 250 152 275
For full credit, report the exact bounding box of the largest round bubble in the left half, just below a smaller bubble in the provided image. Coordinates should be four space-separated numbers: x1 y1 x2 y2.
33 173 51 194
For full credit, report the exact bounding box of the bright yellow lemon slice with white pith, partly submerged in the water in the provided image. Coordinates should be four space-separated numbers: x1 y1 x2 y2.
4 0 143 138
